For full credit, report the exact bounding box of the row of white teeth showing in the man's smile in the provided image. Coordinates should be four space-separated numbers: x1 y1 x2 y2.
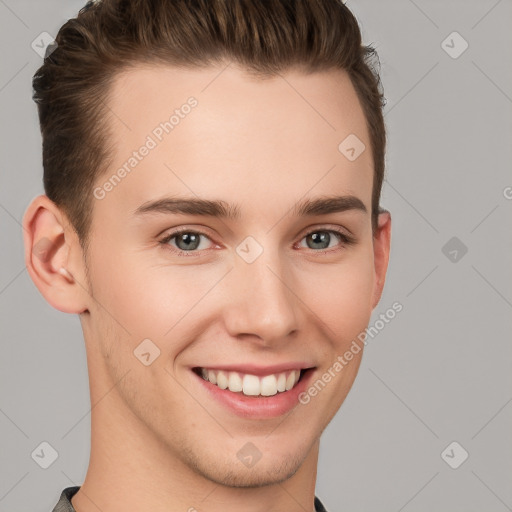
192 367 311 398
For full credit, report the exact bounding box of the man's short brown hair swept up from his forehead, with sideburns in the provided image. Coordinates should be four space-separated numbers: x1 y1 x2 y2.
33 0 386 247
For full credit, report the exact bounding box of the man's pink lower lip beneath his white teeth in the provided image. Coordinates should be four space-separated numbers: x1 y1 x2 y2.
192 368 314 419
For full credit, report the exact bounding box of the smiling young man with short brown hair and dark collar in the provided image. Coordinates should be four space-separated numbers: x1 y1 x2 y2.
23 0 391 512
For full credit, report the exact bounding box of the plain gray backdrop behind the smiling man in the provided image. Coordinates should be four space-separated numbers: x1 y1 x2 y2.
0 0 512 512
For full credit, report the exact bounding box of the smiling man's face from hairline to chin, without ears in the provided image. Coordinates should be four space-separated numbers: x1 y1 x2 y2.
82 65 388 486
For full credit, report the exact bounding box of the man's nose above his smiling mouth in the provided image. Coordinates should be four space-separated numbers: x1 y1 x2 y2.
224 245 300 346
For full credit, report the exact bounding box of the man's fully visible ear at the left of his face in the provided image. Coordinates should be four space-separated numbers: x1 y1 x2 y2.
23 195 91 313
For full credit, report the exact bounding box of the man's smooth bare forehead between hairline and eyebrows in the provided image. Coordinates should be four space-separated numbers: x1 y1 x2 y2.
98 64 373 223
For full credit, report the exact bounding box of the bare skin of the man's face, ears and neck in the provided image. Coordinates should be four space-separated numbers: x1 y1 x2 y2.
23 64 391 512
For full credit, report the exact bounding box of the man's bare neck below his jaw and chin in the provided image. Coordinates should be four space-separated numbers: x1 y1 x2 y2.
71 362 319 512
